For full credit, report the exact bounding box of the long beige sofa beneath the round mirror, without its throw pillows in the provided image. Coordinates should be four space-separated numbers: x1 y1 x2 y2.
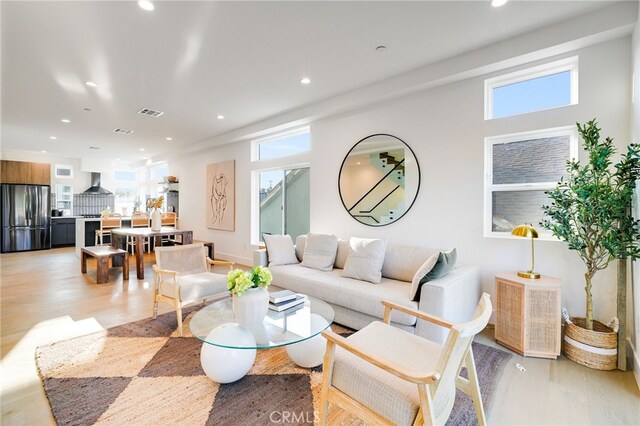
253 235 481 343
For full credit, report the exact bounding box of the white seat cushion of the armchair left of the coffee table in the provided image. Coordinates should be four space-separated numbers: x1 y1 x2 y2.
160 272 228 303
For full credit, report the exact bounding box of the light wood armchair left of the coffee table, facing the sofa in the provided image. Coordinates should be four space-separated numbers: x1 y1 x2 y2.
153 244 235 336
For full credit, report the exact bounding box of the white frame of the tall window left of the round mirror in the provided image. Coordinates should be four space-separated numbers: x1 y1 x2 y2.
250 126 313 246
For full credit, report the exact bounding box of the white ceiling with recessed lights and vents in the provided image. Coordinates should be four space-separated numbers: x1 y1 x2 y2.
0 0 628 166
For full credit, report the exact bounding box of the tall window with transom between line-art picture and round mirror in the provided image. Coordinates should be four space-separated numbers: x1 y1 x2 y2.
252 128 311 242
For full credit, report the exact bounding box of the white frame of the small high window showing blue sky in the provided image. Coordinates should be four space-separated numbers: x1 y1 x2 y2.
484 56 579 120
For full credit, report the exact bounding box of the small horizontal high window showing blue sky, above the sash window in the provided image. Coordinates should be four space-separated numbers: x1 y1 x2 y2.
485 56 578 120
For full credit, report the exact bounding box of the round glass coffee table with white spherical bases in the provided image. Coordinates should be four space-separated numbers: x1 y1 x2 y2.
189 296 334 383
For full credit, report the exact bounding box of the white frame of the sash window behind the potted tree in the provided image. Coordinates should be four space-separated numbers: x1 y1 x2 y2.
482 126 579 241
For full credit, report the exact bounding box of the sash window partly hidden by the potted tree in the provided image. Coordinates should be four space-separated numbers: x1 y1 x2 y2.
484 126 578 237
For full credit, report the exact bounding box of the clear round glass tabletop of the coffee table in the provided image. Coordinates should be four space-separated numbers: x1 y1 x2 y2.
189 295 334 349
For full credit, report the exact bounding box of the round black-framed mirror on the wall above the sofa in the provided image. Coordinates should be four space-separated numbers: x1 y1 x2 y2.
338 134 420 226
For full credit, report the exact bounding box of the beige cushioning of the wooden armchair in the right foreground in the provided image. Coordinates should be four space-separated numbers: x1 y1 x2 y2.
332 321 448 425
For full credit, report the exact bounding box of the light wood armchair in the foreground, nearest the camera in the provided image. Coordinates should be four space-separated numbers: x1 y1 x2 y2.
320 293 492 425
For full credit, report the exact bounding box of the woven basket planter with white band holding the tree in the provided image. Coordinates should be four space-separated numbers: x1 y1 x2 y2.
563 318 618 370
